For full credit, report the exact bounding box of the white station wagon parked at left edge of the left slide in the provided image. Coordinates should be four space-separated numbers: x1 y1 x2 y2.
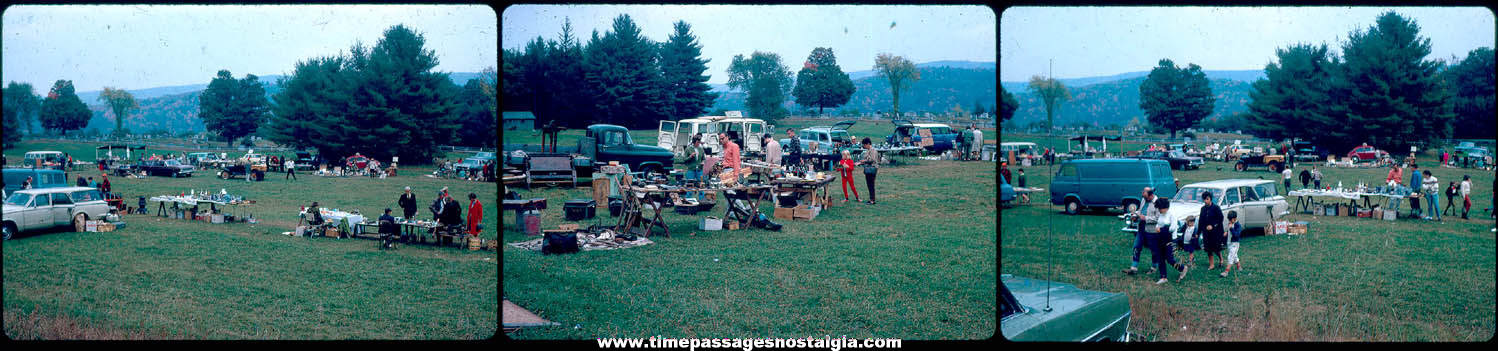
0 186 111 240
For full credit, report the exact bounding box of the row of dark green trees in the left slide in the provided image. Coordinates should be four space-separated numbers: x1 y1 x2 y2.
4 26 499 164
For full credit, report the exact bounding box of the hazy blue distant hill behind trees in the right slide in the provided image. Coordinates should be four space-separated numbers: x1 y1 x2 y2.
1013 77 1252 126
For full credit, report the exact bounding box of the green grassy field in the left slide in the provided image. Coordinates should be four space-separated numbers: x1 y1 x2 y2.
4 143 499 339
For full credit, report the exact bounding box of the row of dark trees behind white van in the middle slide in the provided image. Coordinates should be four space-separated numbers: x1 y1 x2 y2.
503 15 946 129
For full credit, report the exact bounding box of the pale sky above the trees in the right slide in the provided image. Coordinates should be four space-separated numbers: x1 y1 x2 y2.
999 8 1495 81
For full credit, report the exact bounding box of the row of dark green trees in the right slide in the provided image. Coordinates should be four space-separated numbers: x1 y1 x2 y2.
1001 12 1495 150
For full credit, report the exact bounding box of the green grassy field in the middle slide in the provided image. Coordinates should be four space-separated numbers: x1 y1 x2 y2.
503 126 998 339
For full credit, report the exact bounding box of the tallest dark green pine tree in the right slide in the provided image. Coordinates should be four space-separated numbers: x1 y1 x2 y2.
1330 12 1455 150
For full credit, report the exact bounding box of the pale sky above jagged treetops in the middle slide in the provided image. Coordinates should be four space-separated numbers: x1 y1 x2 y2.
500 5 998 84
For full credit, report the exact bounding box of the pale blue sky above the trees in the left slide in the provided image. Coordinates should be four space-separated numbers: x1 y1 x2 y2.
0 5 499 94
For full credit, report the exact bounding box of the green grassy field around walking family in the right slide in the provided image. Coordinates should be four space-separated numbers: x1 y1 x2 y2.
1001 133 1495 341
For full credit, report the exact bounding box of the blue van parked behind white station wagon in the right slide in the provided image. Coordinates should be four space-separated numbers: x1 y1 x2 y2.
1050 159 1176 215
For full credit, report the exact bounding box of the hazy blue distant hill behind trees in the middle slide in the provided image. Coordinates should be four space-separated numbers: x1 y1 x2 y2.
712 62 998 114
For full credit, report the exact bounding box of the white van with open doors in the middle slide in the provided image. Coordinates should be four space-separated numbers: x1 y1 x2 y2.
656 111 770 156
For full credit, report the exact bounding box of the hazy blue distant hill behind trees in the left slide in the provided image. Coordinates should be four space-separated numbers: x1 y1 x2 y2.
78 72 479 132
